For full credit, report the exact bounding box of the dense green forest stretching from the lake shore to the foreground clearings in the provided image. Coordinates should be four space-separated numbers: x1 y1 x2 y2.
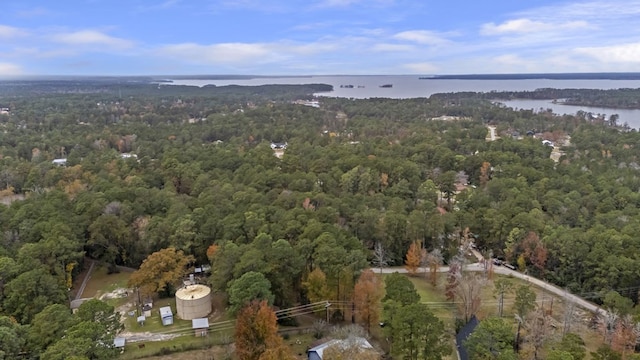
0 79 640 358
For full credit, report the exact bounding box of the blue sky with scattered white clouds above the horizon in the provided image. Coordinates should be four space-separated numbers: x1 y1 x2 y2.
0 0 640 76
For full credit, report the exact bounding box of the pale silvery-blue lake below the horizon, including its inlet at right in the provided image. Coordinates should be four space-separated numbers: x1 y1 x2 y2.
163 75 640 129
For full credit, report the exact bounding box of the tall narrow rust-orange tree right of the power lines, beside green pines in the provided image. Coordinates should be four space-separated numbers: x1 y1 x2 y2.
353 269 384 332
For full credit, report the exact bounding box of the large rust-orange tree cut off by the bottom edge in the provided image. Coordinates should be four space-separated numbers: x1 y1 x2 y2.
235 300 295 360
